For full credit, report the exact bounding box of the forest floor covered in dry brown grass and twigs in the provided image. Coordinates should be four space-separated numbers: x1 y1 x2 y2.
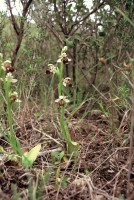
0 105 134 200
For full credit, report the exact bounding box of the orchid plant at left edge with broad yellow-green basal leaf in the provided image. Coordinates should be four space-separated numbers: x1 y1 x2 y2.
0 60 41 167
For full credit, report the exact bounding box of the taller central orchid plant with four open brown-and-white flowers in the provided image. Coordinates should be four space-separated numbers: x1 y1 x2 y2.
46 46 79 157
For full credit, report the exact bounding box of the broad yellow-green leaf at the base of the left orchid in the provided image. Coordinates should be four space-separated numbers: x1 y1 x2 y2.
22 144 41 167
